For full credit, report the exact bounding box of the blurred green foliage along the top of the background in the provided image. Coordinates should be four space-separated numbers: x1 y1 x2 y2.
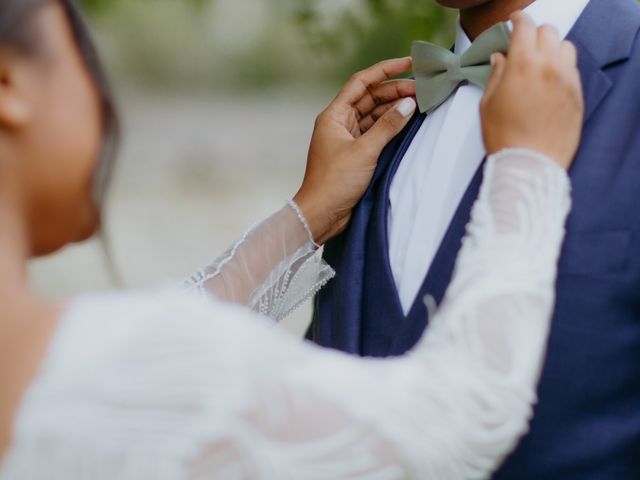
79 0 455 90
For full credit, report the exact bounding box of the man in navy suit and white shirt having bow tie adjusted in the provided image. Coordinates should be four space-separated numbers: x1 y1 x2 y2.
309 0 640 480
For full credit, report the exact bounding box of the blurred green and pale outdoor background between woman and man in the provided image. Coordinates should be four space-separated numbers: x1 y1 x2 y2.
30 0 455 333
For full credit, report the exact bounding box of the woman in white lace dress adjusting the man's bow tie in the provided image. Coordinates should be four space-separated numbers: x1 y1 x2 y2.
0 0 582 480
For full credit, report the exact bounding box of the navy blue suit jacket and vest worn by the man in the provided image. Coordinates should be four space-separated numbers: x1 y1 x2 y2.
309 0 640 480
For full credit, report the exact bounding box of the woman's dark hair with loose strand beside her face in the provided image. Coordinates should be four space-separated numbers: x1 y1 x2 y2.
0 0 120 207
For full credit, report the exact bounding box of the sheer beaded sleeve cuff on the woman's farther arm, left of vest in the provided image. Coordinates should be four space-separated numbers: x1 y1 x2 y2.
185 201 335 321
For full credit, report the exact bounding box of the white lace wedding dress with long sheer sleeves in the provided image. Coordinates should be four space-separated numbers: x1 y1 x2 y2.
0 150 570 480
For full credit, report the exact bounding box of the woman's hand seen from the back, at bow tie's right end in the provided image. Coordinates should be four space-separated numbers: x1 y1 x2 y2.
480 12 584 169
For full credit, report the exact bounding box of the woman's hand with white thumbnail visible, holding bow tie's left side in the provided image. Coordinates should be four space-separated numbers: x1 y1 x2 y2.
294 58 416 244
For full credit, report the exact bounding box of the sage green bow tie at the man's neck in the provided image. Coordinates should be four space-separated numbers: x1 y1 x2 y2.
411 23 511 113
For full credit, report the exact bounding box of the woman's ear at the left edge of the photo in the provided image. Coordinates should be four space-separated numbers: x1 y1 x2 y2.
0 47 33 130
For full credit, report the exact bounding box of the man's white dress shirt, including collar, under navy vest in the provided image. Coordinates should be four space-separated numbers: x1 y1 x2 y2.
388 0 588 315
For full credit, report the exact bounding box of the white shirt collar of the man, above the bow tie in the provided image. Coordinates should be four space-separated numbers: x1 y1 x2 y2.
454 0 589 55
